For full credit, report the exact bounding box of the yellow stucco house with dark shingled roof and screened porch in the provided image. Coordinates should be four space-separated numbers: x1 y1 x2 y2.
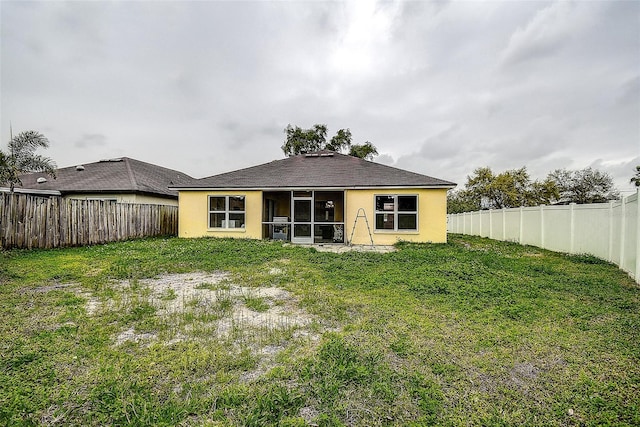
171 150 456 245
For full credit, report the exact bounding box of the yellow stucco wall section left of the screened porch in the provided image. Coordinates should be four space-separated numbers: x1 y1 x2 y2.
178 191 262 239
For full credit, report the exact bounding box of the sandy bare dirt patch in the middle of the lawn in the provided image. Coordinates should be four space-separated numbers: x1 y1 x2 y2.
82 268 325 381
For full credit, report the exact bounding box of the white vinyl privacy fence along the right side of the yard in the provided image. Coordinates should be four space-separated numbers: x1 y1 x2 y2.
447 192 640 283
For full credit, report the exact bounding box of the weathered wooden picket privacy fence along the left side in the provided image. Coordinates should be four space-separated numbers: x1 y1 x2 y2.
0 192 178 249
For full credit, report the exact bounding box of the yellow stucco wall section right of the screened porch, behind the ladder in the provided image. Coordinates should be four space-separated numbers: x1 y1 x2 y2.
345 189 447 245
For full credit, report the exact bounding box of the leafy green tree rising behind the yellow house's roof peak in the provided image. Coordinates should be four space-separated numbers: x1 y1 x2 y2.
280 124 378 160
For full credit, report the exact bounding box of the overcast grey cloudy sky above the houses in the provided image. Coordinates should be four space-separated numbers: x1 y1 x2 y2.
0 1 640 194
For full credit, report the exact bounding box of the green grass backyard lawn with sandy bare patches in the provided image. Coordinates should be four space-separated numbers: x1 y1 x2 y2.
0 235 640 426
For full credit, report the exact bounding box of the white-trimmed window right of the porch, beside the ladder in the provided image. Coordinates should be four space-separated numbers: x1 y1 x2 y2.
375 194 418 231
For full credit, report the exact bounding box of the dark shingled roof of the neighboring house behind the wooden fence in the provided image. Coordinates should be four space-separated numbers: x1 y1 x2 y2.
19 157 193 198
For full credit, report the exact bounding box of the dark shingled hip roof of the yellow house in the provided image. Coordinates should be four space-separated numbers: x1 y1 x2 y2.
172 150 456 190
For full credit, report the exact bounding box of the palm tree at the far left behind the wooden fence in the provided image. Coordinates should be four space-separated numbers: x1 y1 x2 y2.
0 130 56 192
